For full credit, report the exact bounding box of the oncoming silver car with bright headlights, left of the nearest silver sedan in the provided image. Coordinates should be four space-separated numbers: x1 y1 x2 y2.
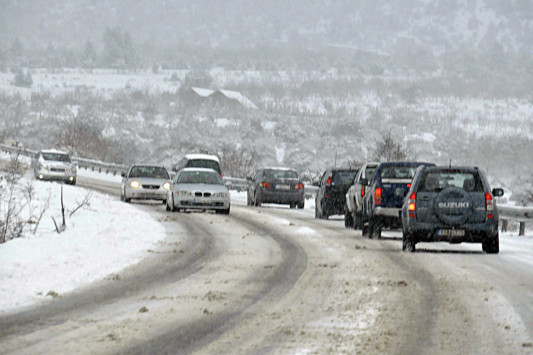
121 164 171 203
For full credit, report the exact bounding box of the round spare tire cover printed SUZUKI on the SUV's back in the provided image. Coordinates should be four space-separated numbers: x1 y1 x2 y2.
435 187 473 224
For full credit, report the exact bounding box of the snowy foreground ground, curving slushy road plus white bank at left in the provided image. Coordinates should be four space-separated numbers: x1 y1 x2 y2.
0 174 533 354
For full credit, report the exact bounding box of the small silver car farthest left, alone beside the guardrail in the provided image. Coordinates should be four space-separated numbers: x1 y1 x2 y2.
31 149 77 185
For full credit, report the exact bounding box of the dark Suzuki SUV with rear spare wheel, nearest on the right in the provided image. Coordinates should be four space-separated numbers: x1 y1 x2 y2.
402 167 503 254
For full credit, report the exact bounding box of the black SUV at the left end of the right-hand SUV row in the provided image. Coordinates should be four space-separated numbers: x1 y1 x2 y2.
315 168 359 219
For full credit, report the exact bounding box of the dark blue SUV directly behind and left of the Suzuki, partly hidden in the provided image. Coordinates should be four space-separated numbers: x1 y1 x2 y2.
362 162 435 238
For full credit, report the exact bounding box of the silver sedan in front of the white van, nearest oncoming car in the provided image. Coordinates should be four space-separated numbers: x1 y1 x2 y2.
167 168 230 214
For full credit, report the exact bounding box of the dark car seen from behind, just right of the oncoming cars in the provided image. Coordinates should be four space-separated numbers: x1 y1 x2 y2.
247 168 305 208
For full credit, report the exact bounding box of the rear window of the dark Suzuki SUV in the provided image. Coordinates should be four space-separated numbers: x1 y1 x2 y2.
418 170 483 192
